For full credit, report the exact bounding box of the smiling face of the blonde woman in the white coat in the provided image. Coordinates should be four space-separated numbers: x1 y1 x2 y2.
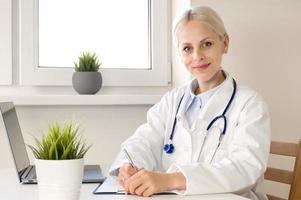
177 20 229 89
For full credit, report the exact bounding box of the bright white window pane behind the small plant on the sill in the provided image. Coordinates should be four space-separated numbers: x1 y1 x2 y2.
38 0 151 69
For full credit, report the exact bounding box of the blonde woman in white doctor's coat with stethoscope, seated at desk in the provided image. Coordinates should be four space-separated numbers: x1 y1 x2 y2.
110 7 270 199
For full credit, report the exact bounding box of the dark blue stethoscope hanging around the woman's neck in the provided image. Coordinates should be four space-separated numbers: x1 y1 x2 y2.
163 79 237 159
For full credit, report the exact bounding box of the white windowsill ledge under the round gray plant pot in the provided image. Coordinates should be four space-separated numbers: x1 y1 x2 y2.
0 86 170 106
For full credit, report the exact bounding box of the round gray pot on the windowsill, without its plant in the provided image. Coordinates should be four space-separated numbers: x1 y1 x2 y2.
72 72 102 94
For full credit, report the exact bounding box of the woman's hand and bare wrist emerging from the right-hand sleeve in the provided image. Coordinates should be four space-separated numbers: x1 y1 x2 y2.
124 169 186 196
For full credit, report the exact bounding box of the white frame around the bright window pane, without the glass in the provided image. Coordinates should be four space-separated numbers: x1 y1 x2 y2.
18 0 171 86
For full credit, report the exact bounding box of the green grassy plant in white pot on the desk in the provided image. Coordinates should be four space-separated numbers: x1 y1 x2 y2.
28 122 91 200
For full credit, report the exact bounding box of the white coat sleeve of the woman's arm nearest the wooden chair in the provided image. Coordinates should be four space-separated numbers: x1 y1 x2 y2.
168 95 270 194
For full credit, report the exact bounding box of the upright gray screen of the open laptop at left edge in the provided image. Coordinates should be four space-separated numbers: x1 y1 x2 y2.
0 102 30 172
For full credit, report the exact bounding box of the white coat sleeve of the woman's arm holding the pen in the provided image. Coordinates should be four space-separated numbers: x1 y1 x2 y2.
109 92 170 176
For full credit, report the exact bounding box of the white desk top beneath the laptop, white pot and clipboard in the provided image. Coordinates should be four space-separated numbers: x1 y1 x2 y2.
0 169 247 200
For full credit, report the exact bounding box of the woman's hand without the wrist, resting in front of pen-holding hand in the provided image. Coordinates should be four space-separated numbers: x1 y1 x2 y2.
124 169 170 196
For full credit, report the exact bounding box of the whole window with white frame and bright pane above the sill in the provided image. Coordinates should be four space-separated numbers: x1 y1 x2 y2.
19 0 171 86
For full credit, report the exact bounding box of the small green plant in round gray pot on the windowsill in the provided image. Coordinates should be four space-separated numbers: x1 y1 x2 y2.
72 52 102 94
